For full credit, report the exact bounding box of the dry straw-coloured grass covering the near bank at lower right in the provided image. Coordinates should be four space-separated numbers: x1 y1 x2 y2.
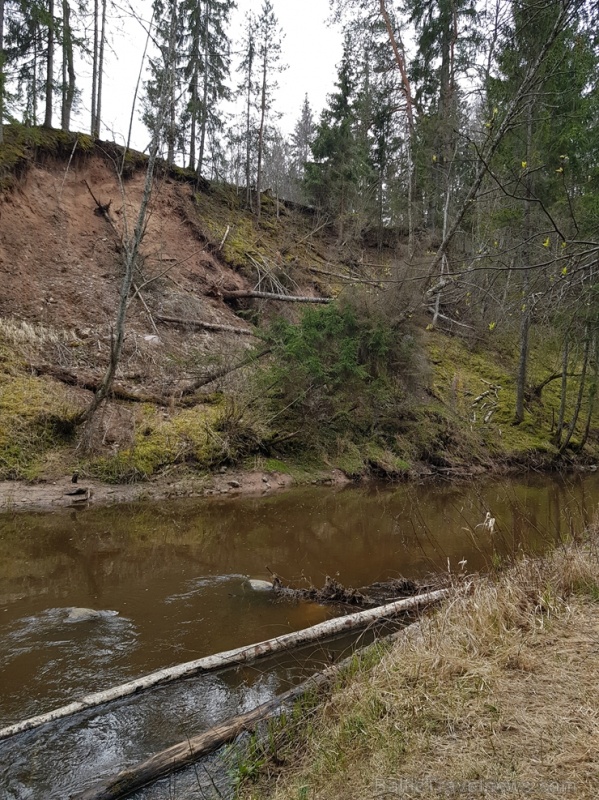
241 534 599 800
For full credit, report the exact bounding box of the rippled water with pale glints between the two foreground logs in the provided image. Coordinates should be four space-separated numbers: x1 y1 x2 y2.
0 674 288 800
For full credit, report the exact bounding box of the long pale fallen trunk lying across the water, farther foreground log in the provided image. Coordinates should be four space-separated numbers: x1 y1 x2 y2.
0 589 449 740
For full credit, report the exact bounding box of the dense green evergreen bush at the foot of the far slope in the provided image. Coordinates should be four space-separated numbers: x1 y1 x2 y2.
266 301 414 443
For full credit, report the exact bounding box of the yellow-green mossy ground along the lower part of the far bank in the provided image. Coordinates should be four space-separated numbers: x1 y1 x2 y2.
0 310 596 481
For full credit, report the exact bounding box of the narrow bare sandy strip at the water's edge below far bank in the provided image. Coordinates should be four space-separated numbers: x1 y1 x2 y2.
0 470 349 511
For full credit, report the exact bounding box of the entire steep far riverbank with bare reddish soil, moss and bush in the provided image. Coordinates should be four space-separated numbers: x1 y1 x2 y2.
0 131 599 509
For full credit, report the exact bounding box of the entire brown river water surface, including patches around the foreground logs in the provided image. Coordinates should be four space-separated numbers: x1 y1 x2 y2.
0 474 599 800
